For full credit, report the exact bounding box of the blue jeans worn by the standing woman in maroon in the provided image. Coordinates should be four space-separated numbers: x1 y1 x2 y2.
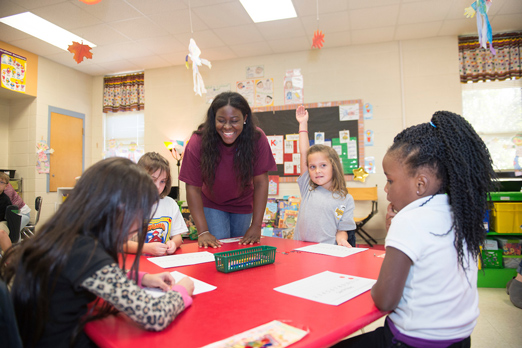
203 208 252 239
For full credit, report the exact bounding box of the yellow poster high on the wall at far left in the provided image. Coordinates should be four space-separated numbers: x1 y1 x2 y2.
0 48 27 93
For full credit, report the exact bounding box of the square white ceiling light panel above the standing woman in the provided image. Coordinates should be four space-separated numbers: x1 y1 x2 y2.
239 0 297 23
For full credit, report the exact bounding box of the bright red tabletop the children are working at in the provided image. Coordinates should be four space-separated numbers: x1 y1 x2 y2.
85 237 386 348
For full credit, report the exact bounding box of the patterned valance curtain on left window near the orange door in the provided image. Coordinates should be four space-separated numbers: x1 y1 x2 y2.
103 72 145 112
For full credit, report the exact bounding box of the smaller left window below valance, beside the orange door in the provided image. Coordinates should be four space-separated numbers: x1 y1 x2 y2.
103 111 145 162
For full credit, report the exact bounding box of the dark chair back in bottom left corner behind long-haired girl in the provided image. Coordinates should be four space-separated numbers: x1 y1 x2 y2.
0 280 22 348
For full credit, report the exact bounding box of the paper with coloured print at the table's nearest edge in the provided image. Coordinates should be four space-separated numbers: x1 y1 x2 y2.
199 320 308 348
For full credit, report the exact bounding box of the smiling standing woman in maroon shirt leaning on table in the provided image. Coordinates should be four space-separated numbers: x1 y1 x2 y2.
180 92 277 248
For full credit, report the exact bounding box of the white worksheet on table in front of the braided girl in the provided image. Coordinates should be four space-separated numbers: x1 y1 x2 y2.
274 271 376 306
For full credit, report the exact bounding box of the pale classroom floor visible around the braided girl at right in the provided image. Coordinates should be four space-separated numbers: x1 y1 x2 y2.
346 240 522 348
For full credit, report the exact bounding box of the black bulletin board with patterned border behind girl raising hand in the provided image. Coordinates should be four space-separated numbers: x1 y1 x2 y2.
253 99 364 182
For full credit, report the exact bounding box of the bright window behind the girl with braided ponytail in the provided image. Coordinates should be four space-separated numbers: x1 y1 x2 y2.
462 80 522 172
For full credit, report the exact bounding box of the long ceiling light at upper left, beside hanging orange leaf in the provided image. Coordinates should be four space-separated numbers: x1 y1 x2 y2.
0 12 96 51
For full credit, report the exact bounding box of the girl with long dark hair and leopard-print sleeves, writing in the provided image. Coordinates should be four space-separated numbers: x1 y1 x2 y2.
0 157 194 348
